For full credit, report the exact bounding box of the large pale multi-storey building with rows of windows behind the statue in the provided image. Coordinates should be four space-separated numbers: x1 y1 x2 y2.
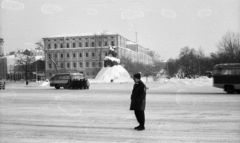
43 33 152 78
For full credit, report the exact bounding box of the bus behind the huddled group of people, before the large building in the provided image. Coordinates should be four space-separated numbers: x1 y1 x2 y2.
50 73 84 89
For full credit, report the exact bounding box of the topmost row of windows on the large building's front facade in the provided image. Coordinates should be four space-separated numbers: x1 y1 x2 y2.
48 41 115 49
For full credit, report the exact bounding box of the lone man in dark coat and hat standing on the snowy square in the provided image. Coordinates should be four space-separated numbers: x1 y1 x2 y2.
130 73 146 131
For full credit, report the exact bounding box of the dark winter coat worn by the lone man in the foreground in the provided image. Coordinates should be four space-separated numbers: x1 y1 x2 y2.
130 81 146 110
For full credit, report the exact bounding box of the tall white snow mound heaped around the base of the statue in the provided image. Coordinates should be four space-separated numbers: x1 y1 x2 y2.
92 65 132 83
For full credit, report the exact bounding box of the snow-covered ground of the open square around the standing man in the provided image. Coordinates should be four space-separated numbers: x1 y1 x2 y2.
0 78 240 143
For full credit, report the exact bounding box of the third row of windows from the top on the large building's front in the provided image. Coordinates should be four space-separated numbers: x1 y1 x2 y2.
48 62 102 69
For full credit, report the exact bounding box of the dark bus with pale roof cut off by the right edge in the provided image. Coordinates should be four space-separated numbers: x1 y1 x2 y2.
213 63 240 94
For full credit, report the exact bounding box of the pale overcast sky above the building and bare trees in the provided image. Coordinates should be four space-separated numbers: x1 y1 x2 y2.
0 0 240 58
